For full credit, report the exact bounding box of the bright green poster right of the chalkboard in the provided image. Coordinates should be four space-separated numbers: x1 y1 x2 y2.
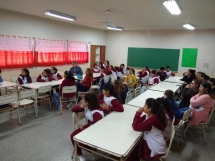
181 48 198 68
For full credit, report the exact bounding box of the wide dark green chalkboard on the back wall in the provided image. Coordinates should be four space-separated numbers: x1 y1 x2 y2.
127 47 180 71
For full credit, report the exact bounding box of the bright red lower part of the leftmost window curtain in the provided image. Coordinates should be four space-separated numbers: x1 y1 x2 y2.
0 50 34 69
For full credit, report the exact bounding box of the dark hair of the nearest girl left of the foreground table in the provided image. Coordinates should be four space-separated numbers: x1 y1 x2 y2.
85 93 100 110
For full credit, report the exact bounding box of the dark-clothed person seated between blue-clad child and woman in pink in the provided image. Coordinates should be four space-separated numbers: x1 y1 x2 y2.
176 79 200 109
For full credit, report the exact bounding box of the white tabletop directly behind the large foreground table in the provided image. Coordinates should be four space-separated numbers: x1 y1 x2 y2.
127 90 164 108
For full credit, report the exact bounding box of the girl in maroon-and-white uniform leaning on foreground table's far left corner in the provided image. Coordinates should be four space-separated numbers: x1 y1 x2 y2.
99 84 124 114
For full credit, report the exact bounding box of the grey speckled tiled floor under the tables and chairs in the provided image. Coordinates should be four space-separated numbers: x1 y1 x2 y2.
0 101 215 161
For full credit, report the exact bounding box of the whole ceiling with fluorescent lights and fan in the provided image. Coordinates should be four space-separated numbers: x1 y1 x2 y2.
0 0 215 30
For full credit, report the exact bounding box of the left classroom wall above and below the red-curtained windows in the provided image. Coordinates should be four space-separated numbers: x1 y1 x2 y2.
0 9 106 80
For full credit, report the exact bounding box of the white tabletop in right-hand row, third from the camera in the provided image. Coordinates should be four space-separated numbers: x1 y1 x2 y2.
149 82 182 93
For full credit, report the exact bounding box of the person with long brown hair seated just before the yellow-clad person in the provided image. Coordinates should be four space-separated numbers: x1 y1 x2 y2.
114 79 128 104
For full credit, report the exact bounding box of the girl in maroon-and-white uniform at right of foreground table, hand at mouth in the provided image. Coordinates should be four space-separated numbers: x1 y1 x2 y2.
132 98 167 160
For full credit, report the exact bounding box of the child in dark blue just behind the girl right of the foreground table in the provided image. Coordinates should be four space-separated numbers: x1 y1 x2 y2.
164 90 181 125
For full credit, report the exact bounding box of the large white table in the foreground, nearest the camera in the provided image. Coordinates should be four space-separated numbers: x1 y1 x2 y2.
74 105 143 161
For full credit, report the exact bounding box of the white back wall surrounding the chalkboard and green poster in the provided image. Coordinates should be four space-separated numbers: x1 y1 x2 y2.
106 30 215 76
